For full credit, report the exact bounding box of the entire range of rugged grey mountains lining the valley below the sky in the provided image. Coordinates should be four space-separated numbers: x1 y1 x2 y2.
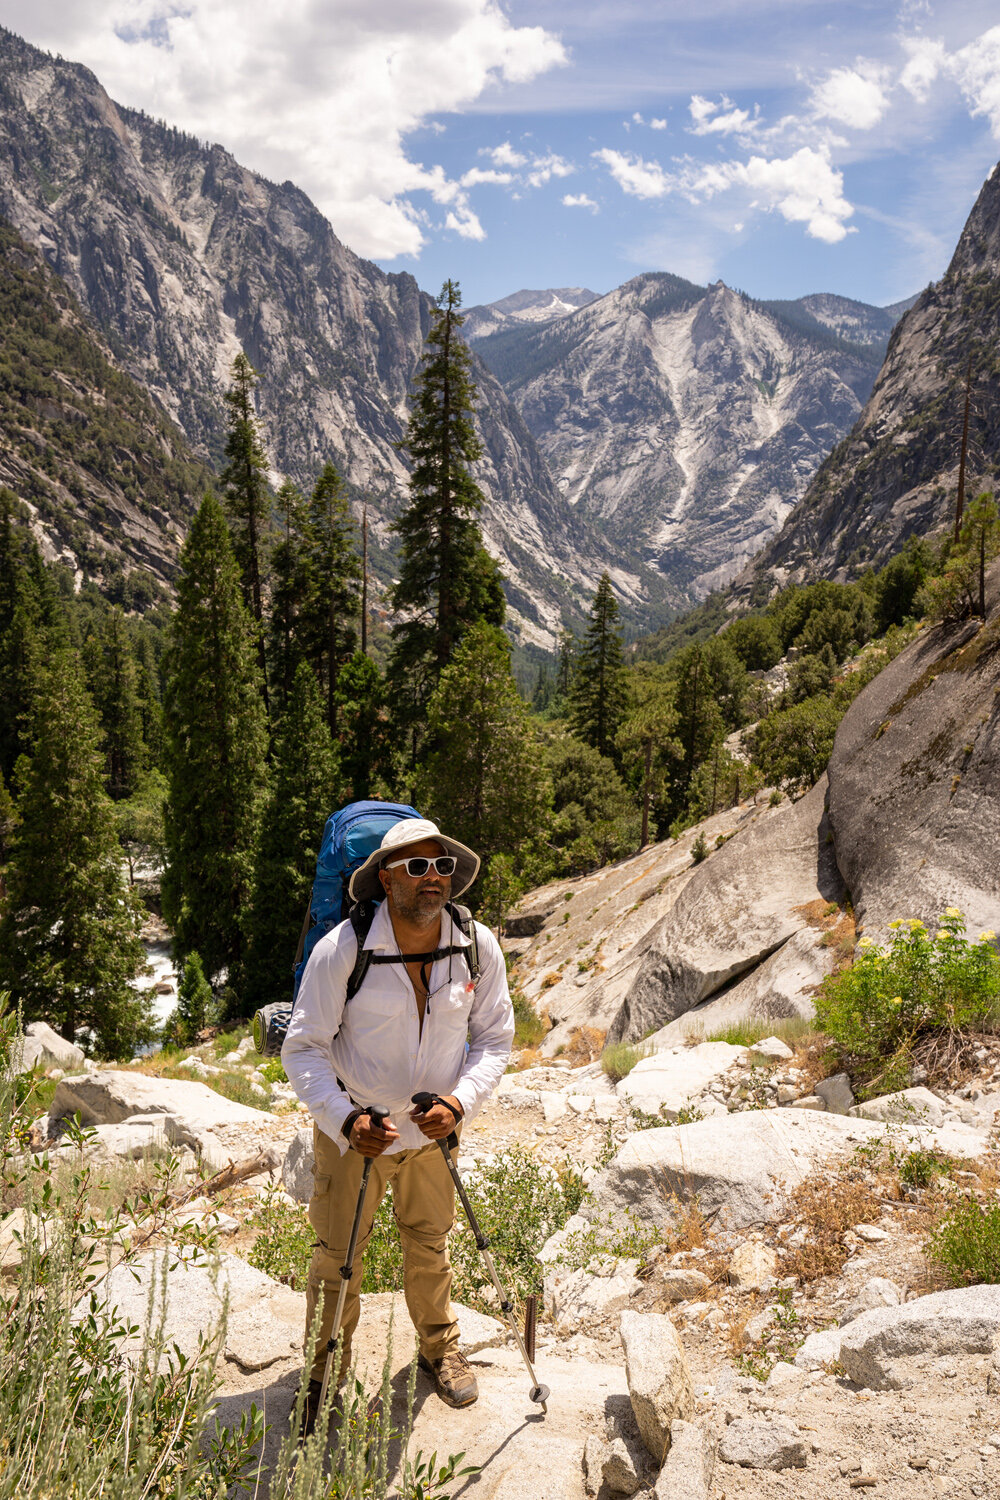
0 21 1000 647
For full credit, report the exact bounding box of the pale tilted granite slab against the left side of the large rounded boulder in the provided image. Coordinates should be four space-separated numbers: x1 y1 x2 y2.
609 779 841 1041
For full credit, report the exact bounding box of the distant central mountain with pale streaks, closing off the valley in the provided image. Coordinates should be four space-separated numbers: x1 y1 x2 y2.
477 275 891 599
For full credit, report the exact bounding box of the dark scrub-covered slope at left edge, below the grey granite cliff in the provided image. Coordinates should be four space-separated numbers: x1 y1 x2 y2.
0 225 211 600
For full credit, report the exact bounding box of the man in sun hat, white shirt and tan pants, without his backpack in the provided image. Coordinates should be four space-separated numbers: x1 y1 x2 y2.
282 819 514 1430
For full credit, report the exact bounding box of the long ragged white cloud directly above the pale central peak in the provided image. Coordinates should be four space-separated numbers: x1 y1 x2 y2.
594 146 855 245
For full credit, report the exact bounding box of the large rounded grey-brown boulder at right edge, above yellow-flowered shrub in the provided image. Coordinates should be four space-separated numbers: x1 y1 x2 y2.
829 563 1000 938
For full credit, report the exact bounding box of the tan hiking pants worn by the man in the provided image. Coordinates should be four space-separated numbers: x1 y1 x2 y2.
306 1127 459 1380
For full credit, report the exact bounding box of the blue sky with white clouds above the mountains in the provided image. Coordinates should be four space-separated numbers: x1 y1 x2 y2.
0 0 1000 306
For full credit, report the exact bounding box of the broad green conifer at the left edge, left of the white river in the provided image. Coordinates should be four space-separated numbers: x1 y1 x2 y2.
0 647 156 1058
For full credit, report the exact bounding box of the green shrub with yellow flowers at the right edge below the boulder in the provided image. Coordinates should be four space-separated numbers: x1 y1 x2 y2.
816 906 1000 1095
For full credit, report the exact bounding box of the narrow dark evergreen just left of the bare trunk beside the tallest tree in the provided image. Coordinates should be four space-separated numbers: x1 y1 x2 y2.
298 464 361 732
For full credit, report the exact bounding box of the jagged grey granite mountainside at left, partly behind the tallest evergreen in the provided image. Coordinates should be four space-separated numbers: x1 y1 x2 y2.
0 32 643 641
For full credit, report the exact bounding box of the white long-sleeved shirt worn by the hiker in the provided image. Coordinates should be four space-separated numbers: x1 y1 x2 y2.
282 903 514 1152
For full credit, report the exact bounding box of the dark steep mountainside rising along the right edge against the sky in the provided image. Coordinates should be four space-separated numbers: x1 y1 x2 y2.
747 168 1000 582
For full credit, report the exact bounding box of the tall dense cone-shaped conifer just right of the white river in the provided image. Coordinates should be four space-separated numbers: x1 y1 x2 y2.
163 492 274 987
